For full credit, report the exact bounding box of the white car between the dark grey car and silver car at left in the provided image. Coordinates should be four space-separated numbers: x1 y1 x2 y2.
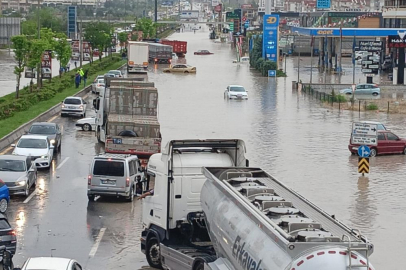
11 135 54 168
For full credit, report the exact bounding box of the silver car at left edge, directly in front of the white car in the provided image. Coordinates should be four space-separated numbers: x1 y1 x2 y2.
0 155 37 197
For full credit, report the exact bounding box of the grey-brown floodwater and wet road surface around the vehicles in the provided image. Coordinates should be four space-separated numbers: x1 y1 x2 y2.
2 27 406 270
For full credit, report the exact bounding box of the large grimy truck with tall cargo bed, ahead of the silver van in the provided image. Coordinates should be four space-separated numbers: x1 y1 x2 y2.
95 75 161 165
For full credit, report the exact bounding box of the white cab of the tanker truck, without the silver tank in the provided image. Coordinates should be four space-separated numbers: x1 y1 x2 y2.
141 140 248 269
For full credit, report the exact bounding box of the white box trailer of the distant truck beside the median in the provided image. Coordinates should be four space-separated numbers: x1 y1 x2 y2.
127 41 149 73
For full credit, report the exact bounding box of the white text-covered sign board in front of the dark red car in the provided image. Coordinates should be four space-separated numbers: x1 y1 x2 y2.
351 122 378 145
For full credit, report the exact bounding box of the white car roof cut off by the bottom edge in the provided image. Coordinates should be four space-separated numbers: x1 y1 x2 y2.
21 257 84 270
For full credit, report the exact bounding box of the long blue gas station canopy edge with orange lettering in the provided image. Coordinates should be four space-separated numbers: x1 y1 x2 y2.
292 27 406 37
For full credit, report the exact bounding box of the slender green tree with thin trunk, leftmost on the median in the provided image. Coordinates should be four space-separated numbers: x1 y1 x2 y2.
11 35 28 98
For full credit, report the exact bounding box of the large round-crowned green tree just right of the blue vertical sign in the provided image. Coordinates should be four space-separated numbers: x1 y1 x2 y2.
85 22 112 61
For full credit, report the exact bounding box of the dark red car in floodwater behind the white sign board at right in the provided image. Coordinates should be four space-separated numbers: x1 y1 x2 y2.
348 130 406 157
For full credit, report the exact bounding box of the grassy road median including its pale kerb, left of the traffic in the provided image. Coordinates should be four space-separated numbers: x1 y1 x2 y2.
0 57 125 153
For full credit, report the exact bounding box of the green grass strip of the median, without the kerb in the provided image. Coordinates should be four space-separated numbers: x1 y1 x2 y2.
0 57 126 138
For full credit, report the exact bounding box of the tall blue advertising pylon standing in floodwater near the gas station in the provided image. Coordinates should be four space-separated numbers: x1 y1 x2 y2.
262 15 279 62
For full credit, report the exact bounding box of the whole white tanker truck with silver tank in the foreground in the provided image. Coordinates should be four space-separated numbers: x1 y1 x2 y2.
141 140 374 270
